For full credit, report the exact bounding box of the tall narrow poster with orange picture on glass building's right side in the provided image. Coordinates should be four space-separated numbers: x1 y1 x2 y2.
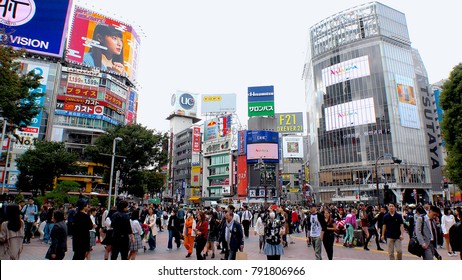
395 75 420 129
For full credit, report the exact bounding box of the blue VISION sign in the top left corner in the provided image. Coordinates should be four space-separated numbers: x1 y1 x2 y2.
0 0 72 57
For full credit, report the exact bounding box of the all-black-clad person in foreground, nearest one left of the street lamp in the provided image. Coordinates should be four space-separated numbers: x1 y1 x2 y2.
72 198 93 260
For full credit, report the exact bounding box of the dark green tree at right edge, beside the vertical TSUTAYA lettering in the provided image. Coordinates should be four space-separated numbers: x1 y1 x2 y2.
440 63 462 188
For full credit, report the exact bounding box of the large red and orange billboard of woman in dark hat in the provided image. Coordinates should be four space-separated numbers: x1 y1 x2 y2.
66 6 140 81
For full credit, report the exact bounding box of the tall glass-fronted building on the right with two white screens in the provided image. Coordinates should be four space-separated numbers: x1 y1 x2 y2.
304 2 442 203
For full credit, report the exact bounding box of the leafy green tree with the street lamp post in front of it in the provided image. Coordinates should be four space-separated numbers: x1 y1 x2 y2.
85 124 168 195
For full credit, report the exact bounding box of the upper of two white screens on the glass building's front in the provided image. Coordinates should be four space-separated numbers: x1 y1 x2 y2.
322 55 371 87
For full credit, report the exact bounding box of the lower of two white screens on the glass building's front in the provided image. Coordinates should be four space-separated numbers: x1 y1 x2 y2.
324 97 375 131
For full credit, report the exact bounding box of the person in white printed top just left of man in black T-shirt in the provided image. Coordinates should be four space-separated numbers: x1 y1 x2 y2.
307 204 327 260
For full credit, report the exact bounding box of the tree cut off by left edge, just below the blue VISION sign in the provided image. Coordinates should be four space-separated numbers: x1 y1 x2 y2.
0 42 45 126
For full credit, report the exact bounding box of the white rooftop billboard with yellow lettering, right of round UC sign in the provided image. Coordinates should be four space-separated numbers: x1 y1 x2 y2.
201 93 236 115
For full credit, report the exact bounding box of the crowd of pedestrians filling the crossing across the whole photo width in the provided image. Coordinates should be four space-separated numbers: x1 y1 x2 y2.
0 198 462 260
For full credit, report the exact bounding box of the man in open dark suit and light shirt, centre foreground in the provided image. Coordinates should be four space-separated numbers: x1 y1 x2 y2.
220 209 244 260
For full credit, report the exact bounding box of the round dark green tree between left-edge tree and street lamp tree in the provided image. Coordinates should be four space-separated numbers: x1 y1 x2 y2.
16 141 78 195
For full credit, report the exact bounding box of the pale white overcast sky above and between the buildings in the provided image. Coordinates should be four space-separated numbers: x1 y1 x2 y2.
74 0 462 131
